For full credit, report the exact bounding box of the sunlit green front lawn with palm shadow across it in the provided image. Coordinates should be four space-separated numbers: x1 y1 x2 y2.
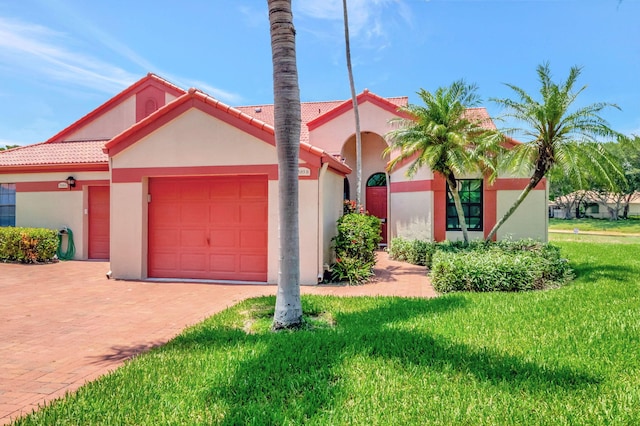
17 242 640 425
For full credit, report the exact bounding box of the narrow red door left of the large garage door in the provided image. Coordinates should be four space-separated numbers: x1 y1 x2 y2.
89 186 110 259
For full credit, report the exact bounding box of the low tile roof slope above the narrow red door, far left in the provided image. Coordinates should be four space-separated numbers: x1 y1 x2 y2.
0 140 108 167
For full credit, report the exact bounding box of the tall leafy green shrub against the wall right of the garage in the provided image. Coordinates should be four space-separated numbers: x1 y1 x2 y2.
331 213 381 284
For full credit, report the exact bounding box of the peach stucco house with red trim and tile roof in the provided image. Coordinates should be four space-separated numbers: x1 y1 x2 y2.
0 74 547 284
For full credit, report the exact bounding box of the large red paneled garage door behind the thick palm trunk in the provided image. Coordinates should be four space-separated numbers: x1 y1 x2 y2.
148 176 268 281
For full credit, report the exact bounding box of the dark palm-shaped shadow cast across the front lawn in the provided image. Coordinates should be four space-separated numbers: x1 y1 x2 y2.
173 296 600 424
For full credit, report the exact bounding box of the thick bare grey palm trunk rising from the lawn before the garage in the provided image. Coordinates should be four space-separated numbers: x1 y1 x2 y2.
267 0 302 329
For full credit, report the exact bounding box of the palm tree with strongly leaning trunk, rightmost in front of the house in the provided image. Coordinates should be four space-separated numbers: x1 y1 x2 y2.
486 63 620 241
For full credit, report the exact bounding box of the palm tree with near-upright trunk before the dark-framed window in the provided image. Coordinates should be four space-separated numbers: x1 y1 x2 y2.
385 80 502 243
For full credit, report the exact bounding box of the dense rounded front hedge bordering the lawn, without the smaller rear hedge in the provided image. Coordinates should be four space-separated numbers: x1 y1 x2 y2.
430 242 572 293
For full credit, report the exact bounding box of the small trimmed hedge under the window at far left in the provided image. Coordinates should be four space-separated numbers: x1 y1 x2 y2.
0 227 58 263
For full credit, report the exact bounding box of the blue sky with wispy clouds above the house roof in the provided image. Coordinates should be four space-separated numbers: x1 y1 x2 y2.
0 0 640 146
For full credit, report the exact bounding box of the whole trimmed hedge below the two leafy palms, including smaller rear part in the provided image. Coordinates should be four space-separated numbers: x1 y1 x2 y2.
389 238 573 293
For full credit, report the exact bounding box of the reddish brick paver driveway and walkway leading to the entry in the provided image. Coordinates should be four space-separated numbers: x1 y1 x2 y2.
0 252 436 424
